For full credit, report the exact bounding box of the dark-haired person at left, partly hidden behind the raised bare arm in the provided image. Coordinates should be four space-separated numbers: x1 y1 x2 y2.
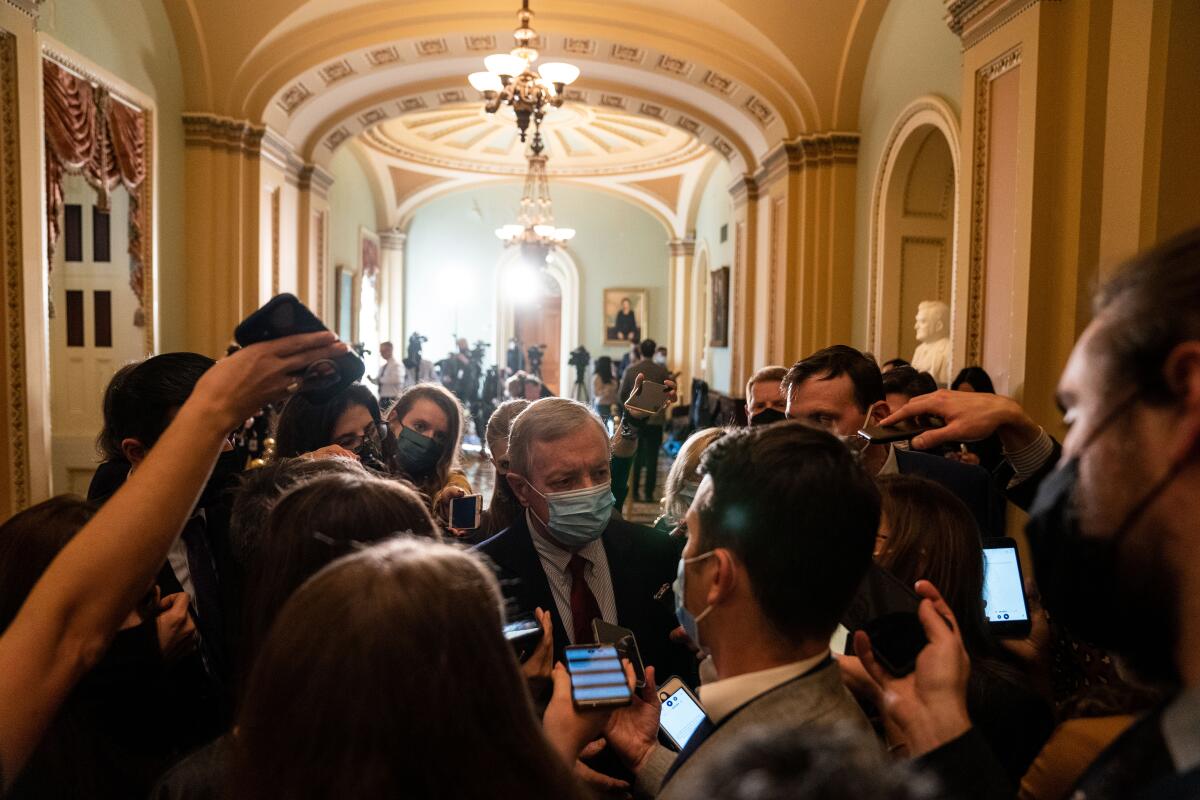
88 353 245 744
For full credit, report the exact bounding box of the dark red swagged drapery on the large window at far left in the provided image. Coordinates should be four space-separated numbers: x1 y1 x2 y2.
42 59 146 327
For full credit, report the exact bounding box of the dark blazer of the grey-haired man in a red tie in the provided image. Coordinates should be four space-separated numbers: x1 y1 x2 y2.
476 513 697 685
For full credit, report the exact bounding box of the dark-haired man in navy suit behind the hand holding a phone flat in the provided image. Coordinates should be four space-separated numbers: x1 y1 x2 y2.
784 344 1004 536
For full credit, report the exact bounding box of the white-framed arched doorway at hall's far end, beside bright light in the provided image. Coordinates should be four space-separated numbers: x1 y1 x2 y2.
493 248 580 397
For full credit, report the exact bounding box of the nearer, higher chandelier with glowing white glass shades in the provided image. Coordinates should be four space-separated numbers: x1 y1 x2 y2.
467 0 580 142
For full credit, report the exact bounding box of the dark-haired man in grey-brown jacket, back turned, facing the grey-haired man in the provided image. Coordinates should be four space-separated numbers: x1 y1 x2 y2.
605 422 880 798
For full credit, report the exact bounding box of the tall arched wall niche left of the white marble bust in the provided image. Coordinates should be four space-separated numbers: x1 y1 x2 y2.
868 98 958 361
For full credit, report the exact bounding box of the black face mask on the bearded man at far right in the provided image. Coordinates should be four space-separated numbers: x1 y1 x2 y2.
1025 401 1183 680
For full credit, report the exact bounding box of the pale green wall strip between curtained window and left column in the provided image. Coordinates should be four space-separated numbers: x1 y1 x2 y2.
38 0 187 351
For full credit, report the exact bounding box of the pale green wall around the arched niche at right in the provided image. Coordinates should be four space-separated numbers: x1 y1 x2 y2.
852 0 962 357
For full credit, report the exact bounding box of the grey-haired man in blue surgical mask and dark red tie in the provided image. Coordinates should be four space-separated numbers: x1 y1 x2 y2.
479 397 696 678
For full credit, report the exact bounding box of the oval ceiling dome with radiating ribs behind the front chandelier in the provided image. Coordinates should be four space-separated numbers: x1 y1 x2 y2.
362 102 708 175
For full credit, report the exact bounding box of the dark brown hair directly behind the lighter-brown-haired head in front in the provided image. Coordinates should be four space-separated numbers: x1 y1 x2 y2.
242 473 442 686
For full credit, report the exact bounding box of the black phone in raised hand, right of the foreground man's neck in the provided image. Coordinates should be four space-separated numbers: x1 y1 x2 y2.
841 564 929 678
